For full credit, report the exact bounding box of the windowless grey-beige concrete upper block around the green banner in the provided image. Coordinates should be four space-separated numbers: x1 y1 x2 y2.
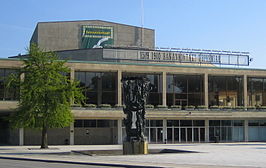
30 20 155 51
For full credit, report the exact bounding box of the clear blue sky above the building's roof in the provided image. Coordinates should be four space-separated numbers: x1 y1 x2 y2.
0 0 266 69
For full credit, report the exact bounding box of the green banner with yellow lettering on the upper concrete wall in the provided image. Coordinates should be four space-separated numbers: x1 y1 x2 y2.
81 25 114 48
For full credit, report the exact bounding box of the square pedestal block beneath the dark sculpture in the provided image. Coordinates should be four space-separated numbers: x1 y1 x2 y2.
123 141 148 155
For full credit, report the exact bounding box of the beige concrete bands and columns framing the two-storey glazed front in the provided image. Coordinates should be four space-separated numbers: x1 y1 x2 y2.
0 60 266 145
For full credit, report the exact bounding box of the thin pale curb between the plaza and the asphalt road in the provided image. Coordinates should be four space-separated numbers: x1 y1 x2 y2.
0 156 163 168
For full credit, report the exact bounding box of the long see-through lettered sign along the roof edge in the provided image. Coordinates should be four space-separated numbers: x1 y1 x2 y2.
103 49 250 66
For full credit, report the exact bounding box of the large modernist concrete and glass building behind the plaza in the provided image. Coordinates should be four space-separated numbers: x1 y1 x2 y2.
0 20 266 145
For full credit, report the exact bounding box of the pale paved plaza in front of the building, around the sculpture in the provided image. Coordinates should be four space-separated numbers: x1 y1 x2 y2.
0 143 266 168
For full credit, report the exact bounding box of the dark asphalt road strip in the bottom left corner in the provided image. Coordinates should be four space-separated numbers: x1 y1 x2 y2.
0 159 130 168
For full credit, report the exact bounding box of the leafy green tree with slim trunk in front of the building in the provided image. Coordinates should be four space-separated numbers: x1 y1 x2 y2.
8 45 84 148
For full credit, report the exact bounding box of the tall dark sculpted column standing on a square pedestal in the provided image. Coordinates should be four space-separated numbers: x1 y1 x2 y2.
122 77 151 142
